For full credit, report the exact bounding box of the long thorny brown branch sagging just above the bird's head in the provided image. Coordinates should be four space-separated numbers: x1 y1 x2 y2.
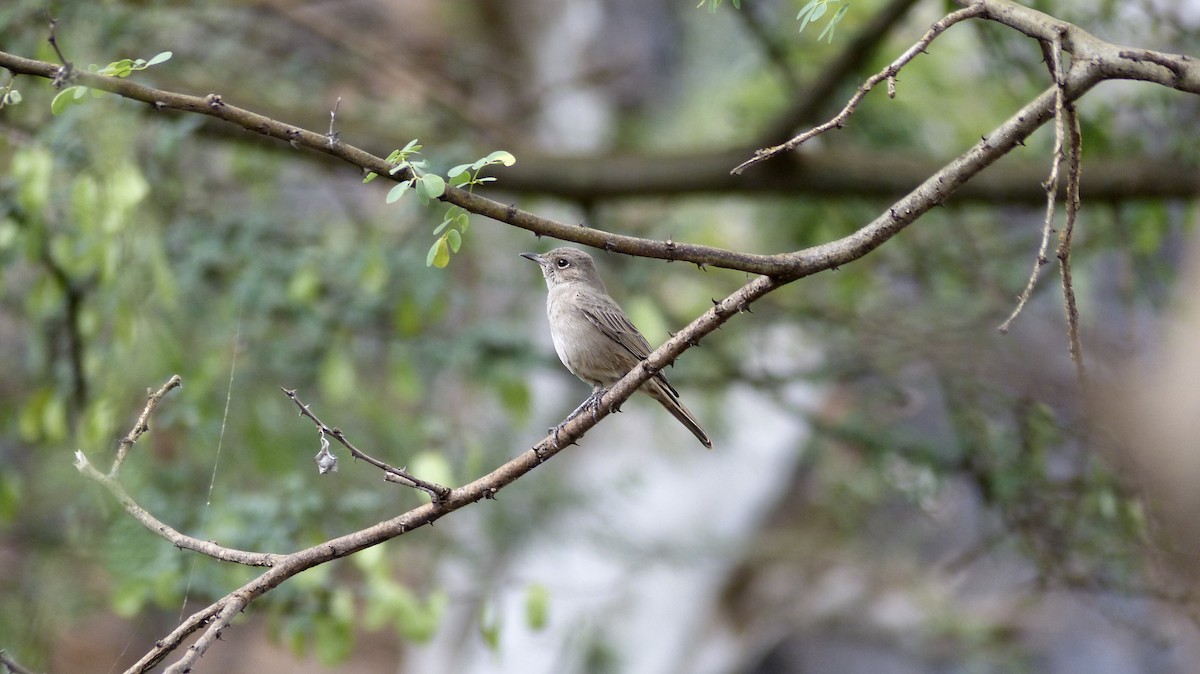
0 24 1200 278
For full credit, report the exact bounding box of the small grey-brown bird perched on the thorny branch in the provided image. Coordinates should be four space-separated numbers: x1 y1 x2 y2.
521 248 713 449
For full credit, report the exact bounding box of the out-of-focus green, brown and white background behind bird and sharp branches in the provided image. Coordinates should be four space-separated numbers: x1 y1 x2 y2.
0 0 1200 674
